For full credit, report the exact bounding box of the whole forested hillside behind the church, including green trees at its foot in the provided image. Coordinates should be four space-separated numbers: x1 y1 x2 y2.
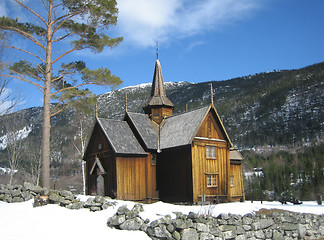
0 63 324 196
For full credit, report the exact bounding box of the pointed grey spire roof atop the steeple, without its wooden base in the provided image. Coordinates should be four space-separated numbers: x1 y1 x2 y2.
144 59 174 108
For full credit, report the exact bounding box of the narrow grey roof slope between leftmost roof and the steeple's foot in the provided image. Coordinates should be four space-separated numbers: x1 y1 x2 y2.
125 112 158 150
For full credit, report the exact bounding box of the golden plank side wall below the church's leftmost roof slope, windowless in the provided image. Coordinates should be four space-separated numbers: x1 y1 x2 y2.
116 157 146 201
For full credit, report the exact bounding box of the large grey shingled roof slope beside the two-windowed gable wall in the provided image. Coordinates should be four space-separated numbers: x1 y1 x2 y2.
160 106 210 149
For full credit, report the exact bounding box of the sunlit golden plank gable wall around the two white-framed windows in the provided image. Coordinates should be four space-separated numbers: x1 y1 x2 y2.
191 111 230 202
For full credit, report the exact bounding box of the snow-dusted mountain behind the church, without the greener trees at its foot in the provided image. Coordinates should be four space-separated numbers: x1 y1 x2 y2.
0 62 324 188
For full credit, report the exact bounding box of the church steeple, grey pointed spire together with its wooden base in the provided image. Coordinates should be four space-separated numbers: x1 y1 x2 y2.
143 59 174 124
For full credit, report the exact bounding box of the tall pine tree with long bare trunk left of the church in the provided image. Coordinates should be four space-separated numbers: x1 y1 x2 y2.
0 0 122 188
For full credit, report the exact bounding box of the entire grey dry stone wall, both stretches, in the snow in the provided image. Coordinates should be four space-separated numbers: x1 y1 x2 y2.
0 182 324 240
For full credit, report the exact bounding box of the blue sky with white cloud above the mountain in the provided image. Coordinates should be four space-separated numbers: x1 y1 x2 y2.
0 0 324 108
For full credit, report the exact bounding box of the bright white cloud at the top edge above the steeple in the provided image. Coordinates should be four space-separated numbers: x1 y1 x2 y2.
118 0 258 47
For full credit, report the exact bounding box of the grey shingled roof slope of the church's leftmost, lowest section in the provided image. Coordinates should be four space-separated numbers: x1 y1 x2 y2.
97 118 147 155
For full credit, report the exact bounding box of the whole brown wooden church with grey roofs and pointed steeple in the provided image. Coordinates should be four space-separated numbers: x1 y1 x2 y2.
84 59 245 203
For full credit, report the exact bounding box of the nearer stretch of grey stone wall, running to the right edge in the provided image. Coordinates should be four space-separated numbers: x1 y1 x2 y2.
107 204 324 240
